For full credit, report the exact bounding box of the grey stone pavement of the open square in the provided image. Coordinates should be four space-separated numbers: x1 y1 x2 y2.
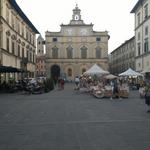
0 84 150 150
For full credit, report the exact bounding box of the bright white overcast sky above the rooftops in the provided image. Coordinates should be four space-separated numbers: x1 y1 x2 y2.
16 0 138 53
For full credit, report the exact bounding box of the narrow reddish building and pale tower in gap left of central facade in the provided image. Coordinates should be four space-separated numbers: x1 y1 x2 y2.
36 35 46 77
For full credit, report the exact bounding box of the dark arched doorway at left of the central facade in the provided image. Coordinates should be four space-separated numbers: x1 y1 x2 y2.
51 65 60 81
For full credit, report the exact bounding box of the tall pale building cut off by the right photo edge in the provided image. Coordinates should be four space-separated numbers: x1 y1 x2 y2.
131 0 150 72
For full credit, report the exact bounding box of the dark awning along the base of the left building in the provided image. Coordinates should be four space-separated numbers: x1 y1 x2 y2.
0 66 24 73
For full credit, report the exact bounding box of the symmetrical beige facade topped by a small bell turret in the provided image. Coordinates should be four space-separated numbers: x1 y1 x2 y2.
45 5 109 80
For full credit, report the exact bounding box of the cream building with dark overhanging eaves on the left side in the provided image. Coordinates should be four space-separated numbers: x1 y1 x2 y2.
0 0 39 79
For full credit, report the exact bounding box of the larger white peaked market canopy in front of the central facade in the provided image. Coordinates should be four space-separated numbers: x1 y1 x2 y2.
84 64 109 75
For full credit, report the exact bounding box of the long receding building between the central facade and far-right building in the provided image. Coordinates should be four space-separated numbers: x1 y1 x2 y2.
110 37 135 75
